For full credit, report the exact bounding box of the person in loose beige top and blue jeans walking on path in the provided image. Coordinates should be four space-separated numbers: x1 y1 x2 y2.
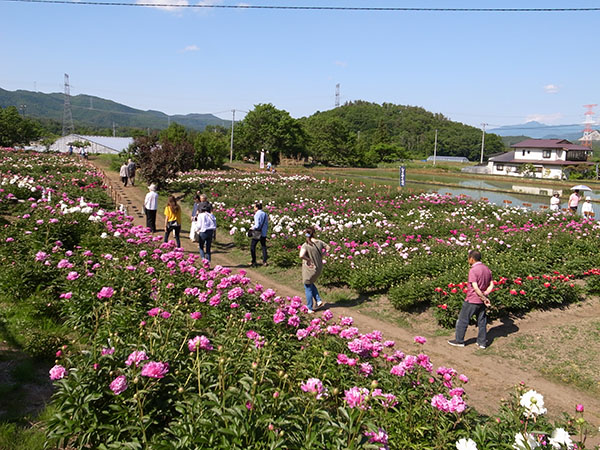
300 227 329 314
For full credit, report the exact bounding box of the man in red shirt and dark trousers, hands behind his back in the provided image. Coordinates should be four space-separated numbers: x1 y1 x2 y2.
448 250 494 348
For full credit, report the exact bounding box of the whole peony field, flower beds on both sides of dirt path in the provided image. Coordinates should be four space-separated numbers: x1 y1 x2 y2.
0 149 598 450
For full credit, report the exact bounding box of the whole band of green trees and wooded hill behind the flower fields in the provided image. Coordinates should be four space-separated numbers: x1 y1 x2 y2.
0 101 505 170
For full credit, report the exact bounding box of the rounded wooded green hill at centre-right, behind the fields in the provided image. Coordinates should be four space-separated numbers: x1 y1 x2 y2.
303 101 504 164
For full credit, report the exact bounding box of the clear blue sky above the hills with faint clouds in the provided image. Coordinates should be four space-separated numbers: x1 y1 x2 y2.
0 0 600 128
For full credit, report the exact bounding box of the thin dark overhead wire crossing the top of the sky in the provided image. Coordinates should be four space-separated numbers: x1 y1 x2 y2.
0 0 600 13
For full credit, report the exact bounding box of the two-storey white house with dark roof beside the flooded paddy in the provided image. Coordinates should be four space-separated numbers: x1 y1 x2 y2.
487 139 594 179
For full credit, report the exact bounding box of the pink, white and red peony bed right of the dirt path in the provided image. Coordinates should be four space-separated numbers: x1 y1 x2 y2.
169 171 600 324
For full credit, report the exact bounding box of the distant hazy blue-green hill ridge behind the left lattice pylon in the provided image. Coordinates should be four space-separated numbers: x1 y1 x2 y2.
0 88 231 130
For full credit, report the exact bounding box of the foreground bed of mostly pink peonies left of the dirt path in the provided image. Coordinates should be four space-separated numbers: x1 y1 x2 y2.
0 153 596 449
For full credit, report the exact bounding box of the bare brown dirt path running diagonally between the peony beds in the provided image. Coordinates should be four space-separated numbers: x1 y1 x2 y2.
91 159 600 436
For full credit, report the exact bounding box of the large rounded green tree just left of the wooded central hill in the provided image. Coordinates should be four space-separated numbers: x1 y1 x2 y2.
234 103 306 164
